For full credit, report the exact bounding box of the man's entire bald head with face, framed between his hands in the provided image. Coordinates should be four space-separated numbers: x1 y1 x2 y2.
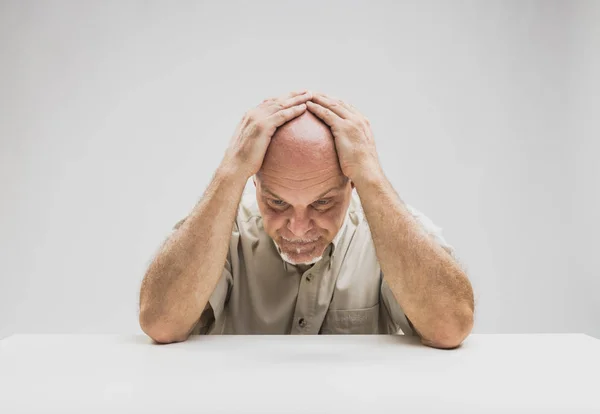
254 112 352 264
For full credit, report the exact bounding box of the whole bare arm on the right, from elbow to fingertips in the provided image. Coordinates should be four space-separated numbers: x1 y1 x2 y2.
307 93 474 348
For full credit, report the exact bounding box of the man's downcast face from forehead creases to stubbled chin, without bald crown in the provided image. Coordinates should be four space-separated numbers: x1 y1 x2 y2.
255 171 352 264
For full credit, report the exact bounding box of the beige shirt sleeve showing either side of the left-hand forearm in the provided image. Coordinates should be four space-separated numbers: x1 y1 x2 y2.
173 218 239 335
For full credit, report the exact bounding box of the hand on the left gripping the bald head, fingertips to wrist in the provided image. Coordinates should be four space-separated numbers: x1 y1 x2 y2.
221 90 312 178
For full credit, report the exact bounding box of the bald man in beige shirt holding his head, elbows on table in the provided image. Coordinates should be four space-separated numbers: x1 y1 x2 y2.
140 90 474 348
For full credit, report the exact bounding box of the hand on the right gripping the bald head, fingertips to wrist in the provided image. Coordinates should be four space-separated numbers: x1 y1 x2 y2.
306 92 381 183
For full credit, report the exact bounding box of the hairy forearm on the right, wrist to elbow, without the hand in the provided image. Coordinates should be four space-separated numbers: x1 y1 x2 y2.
355 167 474 348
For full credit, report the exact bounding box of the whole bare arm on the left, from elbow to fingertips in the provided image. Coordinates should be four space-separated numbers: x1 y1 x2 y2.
139 91 311 343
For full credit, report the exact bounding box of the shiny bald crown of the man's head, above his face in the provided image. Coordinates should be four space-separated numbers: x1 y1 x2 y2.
259 111 342 188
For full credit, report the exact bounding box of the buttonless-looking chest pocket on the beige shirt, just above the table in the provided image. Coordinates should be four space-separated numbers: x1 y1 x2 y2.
319 303 379 335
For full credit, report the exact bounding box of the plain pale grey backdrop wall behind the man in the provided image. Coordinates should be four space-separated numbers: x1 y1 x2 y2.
0 0 600 337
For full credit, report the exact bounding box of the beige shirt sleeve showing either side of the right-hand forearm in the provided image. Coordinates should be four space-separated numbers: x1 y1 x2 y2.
381 205 454 335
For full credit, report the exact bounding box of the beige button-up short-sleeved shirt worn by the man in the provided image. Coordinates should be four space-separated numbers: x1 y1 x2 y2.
185 190 452 335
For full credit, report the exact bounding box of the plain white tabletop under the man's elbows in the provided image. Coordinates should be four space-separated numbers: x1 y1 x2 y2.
0 334 600 414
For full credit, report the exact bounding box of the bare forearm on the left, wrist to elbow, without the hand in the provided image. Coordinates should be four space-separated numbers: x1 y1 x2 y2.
140 164 247 342
